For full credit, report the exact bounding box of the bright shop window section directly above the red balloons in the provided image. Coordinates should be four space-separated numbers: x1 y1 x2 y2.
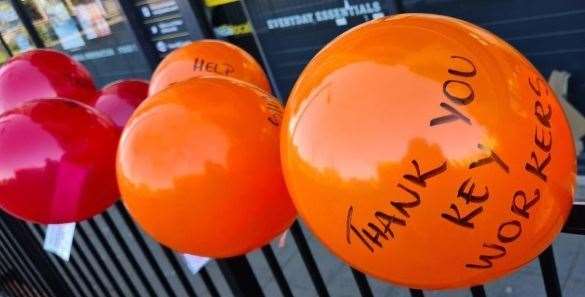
22 0 150 85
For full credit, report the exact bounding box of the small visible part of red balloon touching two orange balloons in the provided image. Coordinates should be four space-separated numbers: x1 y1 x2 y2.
94 79 148 128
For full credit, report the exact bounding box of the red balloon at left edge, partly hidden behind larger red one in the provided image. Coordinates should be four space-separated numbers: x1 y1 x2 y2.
0 49 97 113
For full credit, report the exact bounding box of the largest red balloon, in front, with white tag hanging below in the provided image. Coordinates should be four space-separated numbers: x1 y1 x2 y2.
0 99 120 224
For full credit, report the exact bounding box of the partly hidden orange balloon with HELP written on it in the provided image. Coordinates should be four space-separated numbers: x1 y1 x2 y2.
148 39 271 95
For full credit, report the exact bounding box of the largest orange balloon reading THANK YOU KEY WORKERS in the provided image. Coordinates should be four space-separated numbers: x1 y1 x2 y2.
281 14 576 289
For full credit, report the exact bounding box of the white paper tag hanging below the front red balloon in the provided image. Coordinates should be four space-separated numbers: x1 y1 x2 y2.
43 223 75 261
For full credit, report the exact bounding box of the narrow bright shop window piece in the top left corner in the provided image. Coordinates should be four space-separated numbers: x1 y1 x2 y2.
0 0 34 56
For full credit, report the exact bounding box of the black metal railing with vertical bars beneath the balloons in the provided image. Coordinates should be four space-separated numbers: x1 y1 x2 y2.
0 202 585 297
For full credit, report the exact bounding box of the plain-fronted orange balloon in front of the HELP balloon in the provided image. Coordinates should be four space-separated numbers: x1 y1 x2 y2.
117 77 296 257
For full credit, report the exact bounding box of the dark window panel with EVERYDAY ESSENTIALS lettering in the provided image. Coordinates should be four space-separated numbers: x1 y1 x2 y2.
243 0 394 100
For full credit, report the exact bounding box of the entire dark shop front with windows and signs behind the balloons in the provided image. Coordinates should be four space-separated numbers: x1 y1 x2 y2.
0 0 585 162
